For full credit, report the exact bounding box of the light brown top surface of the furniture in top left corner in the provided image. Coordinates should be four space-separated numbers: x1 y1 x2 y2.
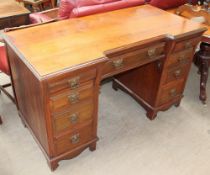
0 0 30 18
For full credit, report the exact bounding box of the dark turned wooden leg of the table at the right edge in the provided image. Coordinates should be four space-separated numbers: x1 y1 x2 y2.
194 42 210 104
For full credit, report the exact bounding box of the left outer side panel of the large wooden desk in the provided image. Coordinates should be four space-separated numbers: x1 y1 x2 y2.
7 45 49 154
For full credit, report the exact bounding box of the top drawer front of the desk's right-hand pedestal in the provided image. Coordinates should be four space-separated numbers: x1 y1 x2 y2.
173 37 201 52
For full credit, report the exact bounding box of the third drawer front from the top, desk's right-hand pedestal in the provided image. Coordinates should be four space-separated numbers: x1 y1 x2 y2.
165 64 190 84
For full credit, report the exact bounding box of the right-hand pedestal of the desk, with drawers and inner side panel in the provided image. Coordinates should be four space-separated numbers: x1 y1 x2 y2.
113 32 202 120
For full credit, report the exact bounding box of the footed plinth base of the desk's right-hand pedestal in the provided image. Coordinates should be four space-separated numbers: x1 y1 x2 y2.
112 79 183 120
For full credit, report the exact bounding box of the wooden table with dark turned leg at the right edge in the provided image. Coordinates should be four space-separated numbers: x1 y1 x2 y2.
175 4 210 104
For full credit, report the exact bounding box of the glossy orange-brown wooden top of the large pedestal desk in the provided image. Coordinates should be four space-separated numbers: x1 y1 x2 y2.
6 5 206 76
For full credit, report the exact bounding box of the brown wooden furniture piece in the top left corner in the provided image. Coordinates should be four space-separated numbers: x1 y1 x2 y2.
0 1 30 30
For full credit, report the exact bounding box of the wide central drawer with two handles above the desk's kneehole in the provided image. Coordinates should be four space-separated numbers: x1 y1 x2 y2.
102 43 165 75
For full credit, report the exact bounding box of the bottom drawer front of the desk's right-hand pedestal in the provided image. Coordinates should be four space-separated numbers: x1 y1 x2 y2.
158 80 184 105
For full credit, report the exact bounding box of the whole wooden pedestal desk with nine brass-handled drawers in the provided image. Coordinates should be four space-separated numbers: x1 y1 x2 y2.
4 5 205 170
